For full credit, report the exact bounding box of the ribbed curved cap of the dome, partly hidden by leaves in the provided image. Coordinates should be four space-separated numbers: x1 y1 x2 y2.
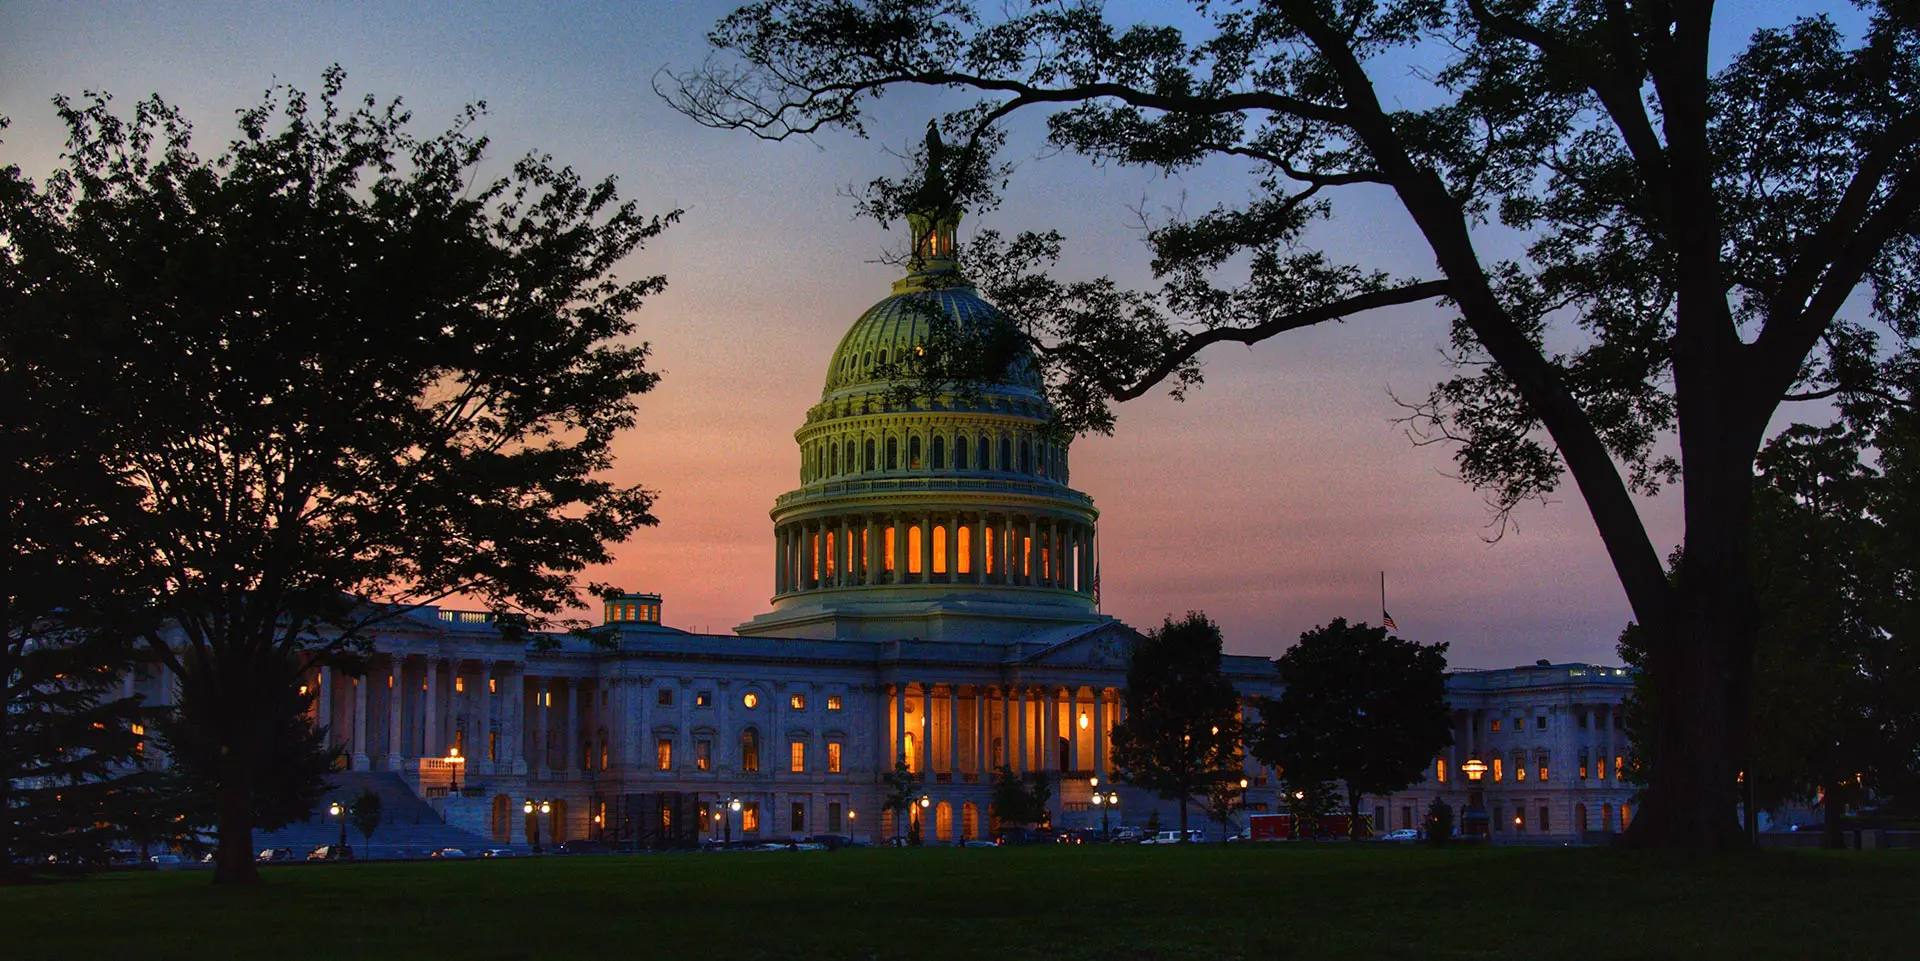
822 286 1039 395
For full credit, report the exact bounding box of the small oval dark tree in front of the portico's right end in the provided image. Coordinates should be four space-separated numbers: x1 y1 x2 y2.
1112 612 1240 840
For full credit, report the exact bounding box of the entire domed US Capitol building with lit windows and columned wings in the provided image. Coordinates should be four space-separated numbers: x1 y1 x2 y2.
129 215 1632 854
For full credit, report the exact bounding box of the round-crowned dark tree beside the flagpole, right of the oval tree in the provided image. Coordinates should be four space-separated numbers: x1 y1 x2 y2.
1252 618 1453 838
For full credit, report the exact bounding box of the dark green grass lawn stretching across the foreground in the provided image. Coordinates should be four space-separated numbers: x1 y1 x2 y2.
0 844 1920 961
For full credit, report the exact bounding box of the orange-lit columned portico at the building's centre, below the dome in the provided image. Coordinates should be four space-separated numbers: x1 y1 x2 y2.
879 683 1123 783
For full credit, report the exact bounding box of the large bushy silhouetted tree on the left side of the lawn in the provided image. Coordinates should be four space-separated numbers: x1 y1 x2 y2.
6 67 672 882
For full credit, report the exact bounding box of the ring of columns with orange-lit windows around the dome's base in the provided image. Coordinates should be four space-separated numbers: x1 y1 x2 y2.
774 508 1096 595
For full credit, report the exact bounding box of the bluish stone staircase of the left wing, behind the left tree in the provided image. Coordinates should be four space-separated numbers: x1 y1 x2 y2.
253 771 501 857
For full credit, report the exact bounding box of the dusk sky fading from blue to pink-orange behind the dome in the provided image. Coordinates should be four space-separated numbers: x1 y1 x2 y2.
0 0 1851 668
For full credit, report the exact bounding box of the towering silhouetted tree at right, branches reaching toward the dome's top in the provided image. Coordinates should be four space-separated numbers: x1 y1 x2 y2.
659 0 1920 846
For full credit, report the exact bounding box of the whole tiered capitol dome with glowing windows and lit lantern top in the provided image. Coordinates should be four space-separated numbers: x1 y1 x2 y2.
739 211 1106 641
